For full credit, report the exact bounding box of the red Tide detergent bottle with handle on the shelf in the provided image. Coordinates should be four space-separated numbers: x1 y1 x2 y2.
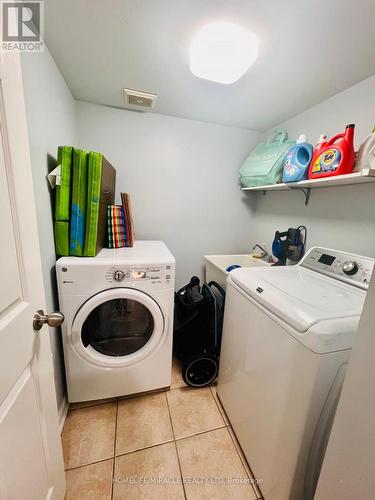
309 123 355 179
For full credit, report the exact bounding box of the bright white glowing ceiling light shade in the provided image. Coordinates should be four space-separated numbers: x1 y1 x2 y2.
190 22 258 84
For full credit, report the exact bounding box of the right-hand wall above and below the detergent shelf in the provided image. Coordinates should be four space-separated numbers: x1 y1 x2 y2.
247 76 375 257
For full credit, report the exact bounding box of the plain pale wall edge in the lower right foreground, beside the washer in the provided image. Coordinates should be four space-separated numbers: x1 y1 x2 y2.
315 268 375 500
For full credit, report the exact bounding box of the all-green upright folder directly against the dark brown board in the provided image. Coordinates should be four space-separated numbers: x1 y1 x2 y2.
83 151 103 257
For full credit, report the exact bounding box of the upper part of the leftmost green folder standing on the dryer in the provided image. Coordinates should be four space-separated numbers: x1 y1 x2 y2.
55 146 73 221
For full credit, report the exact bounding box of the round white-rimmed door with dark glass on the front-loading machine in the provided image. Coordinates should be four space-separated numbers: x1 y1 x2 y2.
69 288 165 367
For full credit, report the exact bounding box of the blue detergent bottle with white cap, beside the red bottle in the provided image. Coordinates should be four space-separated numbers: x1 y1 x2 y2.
283 134 314 182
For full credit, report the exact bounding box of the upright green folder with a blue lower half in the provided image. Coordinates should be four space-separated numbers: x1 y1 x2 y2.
69 149 88 257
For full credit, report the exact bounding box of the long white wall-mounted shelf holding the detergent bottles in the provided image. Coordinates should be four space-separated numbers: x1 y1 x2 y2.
241 169 375 205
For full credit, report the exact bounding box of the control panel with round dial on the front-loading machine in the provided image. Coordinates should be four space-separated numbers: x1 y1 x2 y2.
105 265 173 284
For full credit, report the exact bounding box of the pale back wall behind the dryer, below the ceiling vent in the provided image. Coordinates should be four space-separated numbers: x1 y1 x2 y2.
77 102 259 286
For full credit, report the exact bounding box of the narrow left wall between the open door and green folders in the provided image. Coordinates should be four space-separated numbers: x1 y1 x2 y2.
22 48 76 418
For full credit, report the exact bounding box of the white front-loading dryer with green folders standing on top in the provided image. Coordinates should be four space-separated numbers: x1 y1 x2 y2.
56 241 175 402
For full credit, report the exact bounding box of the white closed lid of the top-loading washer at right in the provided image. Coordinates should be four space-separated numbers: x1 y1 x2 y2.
229 266 366 333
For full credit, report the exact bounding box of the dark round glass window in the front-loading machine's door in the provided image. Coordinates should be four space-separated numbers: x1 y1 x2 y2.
81 298 154 356
